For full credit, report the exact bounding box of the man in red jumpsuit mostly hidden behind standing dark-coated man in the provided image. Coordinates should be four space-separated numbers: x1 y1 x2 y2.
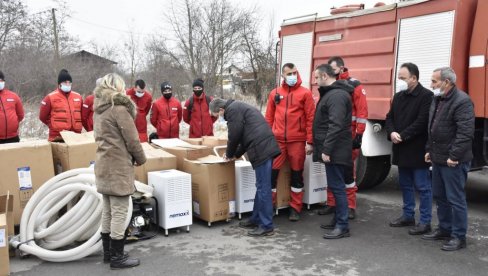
318 56 368 219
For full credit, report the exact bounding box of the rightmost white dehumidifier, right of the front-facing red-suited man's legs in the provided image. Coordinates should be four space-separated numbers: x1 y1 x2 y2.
303 155 327 209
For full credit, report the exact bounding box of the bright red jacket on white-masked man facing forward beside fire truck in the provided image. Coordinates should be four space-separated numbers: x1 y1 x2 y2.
265 74 315 144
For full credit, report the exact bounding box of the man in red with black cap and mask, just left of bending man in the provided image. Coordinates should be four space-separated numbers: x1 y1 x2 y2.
183 79 217 138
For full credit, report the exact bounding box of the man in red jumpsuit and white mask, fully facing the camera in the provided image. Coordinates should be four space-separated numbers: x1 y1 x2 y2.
265 63 315 221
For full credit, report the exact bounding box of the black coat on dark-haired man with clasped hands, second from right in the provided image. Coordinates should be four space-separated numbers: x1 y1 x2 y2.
385 83 433 168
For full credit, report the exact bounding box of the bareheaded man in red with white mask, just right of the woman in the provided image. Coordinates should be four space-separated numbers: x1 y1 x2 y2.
127 80 152 142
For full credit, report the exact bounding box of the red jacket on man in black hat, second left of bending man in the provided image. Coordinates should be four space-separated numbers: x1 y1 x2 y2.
151 97 182 139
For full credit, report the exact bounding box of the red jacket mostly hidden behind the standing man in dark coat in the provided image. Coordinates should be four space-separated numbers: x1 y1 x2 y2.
338 68 368 137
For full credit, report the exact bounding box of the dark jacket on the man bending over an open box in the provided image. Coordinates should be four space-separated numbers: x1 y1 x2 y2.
224 100 281 168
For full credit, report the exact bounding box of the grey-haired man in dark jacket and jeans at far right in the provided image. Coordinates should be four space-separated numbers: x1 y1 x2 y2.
422 67 475 251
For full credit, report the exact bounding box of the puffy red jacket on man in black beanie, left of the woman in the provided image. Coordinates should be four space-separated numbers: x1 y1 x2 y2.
39 89 83 141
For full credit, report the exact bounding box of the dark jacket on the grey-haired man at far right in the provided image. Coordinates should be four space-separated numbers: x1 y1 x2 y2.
426 87 475 165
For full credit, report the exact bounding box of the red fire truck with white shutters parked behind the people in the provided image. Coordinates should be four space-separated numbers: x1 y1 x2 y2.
279 0 488 188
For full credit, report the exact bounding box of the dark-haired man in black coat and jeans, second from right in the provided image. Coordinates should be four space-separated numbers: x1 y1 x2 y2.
386 63 432 235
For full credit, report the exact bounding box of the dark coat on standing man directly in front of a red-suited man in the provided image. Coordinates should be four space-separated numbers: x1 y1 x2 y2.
312 80 354 166
